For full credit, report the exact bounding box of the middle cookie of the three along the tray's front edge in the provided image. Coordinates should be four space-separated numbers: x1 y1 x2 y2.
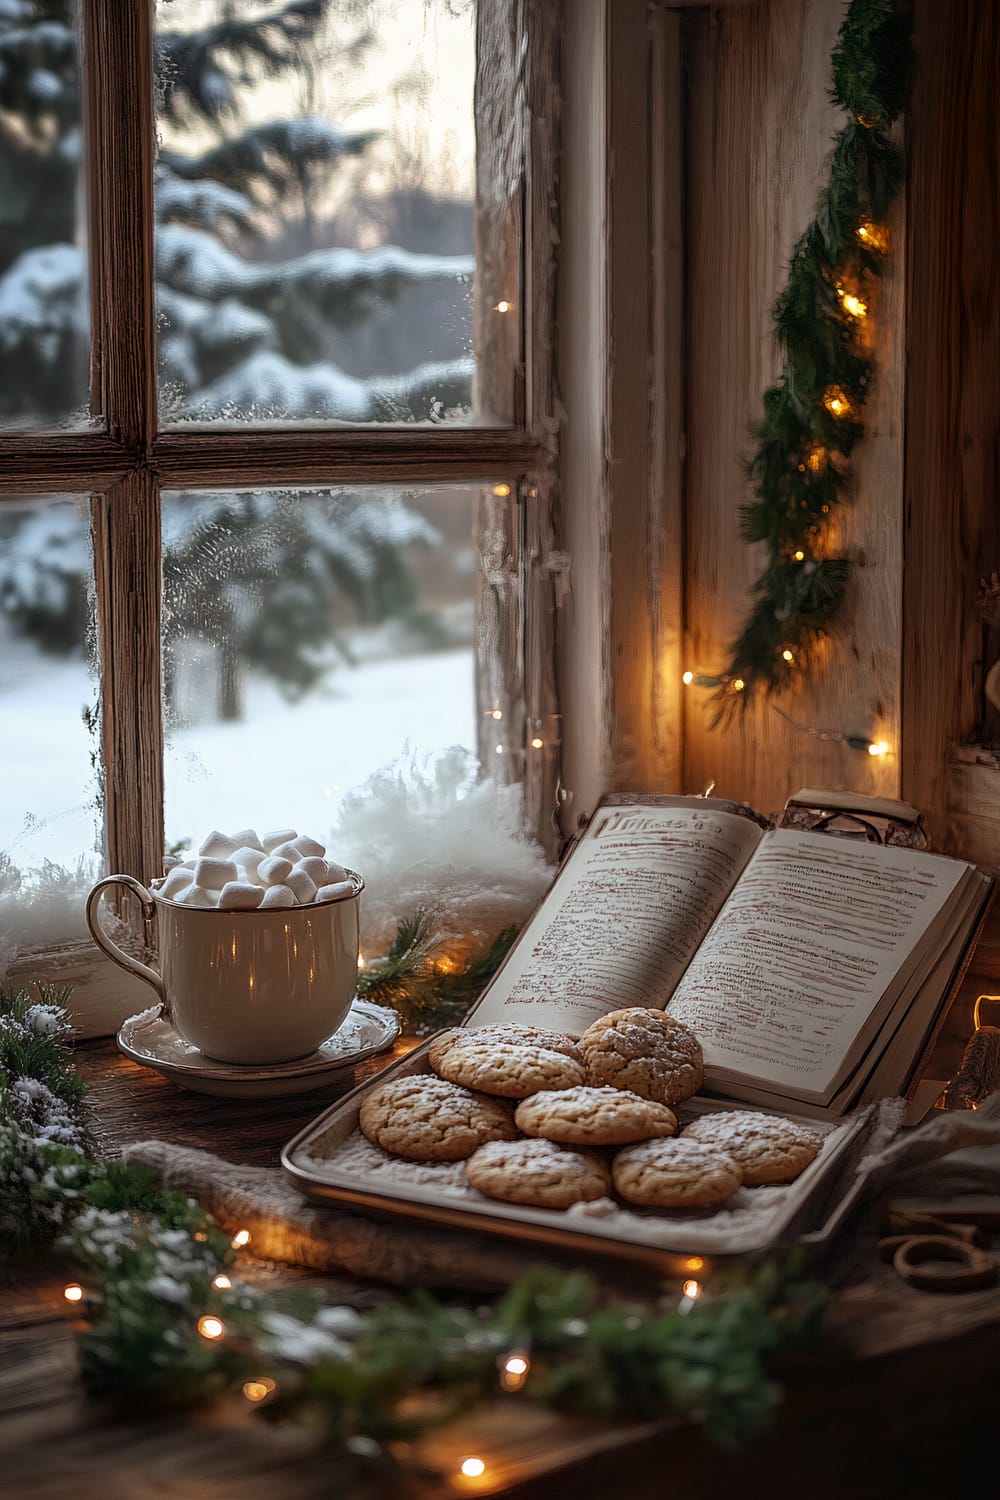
612 1136 744 1209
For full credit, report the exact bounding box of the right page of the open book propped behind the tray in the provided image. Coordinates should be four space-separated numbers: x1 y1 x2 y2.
669 830 970 1103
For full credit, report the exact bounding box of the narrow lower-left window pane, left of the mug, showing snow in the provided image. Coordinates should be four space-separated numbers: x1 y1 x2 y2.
0 500 102 953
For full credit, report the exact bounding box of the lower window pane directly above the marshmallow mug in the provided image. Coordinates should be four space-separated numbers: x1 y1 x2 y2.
163 486 480 846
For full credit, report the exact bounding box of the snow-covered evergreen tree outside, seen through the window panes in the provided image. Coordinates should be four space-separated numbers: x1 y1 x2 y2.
0 0 474 708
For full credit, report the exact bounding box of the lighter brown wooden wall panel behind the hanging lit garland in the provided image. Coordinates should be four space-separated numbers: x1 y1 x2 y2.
682 0 905 812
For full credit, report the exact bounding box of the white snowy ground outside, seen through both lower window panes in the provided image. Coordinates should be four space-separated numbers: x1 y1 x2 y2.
0 642 475 869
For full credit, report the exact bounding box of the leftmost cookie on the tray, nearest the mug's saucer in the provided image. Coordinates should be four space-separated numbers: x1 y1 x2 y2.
358 1073 517 1161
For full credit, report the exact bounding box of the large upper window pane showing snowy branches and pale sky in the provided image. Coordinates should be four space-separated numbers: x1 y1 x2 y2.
156 0 494 423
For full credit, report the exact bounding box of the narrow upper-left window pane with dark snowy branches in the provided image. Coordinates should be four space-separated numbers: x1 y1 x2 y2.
0 0 90 429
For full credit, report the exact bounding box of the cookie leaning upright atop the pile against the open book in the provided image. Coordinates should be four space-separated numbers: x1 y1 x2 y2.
580 1005 705 1104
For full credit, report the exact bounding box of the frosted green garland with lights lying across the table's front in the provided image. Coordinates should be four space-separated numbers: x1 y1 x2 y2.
0 990 823 1473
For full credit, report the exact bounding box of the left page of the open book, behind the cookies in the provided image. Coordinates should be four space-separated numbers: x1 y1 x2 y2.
466 803 762 1034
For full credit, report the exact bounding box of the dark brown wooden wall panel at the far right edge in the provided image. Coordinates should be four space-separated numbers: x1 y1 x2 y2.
903 0 1000 864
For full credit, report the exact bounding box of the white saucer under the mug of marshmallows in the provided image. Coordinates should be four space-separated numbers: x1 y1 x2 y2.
117 999 399 1100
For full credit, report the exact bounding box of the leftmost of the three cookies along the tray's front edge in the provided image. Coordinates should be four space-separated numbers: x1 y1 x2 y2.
465 1140 612 1209
